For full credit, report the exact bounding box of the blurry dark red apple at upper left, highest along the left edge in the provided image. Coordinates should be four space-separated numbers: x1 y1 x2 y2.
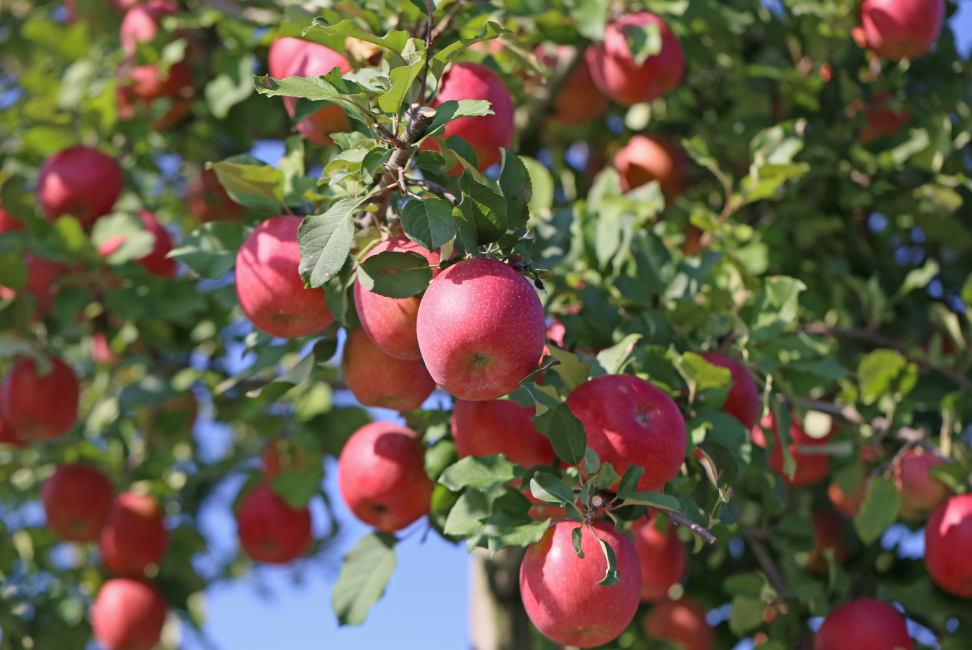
37 147 125 228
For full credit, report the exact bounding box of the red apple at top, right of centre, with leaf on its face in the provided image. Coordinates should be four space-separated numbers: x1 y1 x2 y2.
587 12 685 106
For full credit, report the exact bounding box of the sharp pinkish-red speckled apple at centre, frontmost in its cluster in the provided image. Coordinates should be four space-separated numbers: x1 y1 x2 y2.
416 258 547 401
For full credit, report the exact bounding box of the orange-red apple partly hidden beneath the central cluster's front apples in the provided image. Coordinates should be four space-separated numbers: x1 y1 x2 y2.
341 329 435 413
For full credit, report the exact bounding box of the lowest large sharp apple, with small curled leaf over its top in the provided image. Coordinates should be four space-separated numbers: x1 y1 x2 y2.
520 520 641 648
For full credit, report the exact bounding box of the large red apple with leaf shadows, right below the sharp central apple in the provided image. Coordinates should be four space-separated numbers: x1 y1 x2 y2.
566 375 688 492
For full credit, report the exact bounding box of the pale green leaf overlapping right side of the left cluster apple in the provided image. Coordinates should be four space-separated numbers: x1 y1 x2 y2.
297 198 362 288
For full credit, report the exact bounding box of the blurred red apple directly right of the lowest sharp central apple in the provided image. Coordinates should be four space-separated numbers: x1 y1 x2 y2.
631 518 688 602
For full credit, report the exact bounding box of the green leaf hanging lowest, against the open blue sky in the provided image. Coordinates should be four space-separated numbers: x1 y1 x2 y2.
331 533 398 625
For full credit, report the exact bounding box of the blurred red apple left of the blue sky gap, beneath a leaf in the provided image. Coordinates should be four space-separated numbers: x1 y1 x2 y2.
236 484 311 564
